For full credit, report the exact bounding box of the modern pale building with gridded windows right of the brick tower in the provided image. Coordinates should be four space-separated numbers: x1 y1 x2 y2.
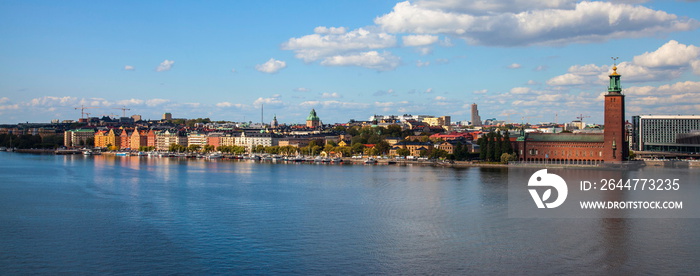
632 115 700 153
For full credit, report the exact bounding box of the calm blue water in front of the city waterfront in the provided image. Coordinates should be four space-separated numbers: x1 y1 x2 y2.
0 153 700 275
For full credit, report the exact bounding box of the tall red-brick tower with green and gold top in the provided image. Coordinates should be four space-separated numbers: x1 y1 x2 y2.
603 62 629 162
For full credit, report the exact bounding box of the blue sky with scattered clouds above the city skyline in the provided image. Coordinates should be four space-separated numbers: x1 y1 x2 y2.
0 0 700 124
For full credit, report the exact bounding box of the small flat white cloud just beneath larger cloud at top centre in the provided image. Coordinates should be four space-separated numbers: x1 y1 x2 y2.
321 51 401 71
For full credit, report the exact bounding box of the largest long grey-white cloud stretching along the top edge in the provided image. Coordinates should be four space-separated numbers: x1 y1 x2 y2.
375 0 699 46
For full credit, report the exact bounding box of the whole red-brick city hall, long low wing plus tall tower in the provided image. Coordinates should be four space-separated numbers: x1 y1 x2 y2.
514 66 629 164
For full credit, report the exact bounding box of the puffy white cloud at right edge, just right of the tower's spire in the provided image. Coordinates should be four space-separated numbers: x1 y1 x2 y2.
634 40 700 67
